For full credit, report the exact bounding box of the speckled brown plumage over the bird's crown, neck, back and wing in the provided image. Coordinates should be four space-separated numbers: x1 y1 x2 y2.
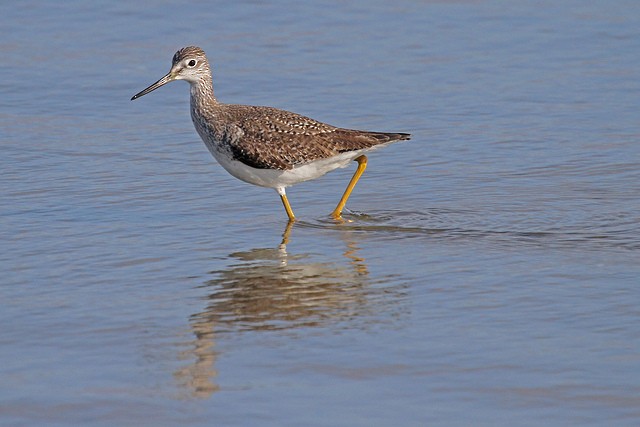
173 47 410 170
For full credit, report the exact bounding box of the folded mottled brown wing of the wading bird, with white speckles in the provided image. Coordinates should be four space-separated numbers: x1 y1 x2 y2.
222 105 410 170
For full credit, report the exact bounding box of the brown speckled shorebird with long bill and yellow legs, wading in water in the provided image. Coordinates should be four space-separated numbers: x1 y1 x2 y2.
131 46 411 223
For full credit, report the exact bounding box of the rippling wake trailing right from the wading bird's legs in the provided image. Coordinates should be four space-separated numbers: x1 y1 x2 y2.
296 208 640 251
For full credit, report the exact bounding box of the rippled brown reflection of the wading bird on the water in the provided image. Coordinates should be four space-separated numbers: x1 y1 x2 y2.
176 223 399 398
